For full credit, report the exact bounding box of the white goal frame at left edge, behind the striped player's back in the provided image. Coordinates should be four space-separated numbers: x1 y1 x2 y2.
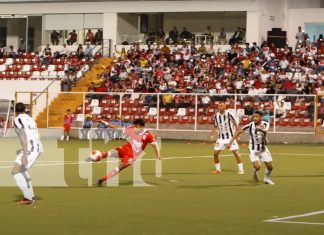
0 99 14 137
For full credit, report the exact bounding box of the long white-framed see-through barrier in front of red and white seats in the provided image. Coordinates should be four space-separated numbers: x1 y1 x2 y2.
17 92 323 131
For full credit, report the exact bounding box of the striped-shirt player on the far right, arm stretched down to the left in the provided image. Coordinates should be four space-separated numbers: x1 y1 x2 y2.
228 111 274 185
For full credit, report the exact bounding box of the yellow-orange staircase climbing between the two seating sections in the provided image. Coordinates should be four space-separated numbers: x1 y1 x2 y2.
36 58 111 128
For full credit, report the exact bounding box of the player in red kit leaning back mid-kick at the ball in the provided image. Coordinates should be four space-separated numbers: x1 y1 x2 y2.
91 118 161 187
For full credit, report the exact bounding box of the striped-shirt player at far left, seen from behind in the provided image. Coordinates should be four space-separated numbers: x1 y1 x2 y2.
11 103 43 205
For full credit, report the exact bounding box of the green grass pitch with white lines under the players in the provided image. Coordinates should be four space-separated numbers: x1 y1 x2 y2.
0 139 324 235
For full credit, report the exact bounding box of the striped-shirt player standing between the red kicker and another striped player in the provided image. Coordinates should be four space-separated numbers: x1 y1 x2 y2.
210 101 244 175
